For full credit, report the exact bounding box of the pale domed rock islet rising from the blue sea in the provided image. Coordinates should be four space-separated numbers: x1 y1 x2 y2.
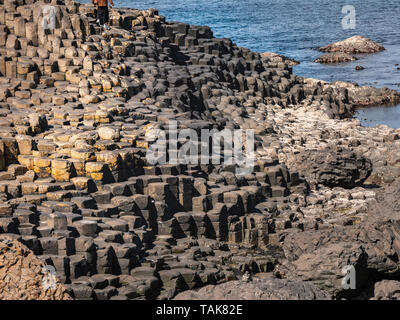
318 36 385 54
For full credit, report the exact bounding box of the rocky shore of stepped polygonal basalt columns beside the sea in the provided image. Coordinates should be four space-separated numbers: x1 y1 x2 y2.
0 0 400 300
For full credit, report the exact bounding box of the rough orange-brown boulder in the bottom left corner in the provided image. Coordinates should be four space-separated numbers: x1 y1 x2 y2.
0 237 71 300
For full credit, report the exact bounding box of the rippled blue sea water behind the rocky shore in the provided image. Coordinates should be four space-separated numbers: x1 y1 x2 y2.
84 0 400 127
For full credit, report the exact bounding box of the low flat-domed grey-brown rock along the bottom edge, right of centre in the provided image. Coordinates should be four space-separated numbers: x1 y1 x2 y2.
174 279 327 300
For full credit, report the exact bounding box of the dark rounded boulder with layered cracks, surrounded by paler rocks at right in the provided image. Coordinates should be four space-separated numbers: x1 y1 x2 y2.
292 146 372 188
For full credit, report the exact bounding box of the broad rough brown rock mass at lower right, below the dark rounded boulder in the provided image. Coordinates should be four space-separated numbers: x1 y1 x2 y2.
282 219 400 296
